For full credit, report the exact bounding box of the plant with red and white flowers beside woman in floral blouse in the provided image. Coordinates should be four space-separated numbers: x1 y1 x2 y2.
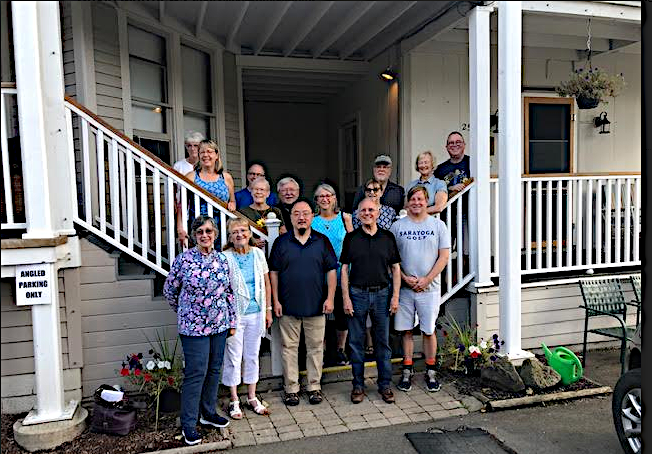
120 331 183 430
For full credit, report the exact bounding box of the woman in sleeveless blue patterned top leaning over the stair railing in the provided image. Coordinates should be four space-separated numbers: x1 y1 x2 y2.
177 140 235 249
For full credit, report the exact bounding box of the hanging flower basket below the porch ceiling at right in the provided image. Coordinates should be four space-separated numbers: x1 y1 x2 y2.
555 67 625 109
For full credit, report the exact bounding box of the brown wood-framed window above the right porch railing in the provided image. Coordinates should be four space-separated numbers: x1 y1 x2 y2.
524 98 573 174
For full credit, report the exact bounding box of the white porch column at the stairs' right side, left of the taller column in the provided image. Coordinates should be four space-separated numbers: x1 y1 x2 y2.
469 6 493 287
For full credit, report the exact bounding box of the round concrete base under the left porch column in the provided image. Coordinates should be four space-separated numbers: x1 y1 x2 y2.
13 405 88 452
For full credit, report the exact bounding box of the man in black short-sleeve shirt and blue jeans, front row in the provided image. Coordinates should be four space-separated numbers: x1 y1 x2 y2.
340 198 401 403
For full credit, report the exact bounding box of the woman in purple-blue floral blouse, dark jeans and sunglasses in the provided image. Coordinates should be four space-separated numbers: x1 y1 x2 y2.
163 215 238 445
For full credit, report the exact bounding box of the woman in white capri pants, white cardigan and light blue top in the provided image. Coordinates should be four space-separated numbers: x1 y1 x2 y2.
222 218 272 419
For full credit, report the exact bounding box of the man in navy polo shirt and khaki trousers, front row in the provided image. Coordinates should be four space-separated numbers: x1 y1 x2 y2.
269 198 337 405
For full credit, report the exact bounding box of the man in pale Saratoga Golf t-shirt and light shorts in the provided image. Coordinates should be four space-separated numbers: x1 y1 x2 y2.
390 185 451 392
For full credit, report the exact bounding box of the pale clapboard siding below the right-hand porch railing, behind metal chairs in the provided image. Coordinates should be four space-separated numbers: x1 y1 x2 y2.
472 283 636 351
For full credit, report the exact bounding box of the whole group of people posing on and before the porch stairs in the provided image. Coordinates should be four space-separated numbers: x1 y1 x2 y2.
163 132 470 444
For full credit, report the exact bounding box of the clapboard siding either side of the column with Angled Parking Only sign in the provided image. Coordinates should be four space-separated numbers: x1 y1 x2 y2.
0 270 82 413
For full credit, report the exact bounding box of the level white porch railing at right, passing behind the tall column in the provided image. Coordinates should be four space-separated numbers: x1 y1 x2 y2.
491 174 641 276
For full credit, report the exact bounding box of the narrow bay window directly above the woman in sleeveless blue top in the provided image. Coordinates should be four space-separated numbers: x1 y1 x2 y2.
181 44 215 137
